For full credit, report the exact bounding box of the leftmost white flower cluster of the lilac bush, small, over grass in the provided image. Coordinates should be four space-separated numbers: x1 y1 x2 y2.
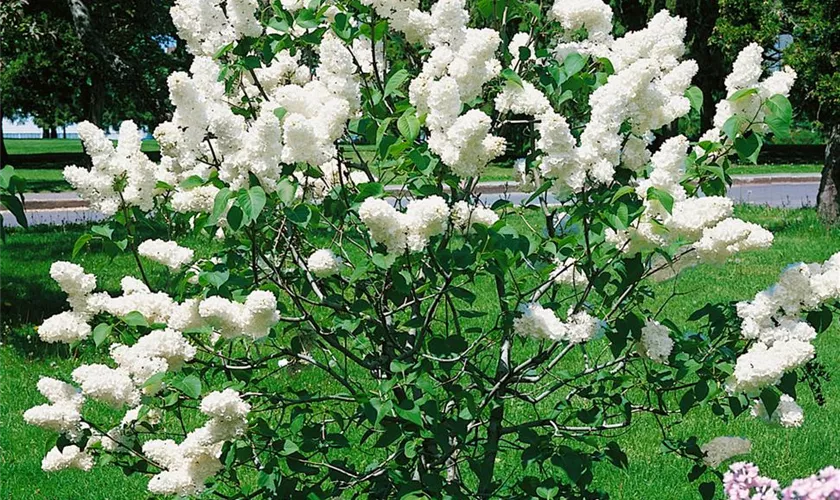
23 377 85 436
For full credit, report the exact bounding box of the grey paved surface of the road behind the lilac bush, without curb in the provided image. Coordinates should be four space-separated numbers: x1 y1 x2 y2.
0 182 819 227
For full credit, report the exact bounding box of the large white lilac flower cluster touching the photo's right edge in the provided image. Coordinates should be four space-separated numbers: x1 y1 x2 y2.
727 253 840 393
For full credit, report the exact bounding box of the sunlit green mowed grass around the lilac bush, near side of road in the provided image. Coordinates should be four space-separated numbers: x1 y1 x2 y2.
0 207 840 500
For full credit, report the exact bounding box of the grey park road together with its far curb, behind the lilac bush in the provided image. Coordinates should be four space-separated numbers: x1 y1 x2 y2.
0 174 820 227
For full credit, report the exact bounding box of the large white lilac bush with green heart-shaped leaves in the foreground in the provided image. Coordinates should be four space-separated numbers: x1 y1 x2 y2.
24 0 840 498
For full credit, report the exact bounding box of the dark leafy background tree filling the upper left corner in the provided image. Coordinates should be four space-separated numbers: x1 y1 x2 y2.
0 0 188 161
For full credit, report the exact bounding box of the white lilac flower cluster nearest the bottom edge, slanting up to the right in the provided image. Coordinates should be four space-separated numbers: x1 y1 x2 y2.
143 389 251 496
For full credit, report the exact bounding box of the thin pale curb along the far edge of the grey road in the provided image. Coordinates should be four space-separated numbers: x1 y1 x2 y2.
13 174 820 211
